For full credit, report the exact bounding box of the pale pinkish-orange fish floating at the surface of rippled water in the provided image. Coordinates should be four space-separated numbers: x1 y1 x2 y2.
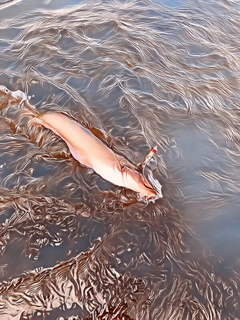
30 112 161 200
